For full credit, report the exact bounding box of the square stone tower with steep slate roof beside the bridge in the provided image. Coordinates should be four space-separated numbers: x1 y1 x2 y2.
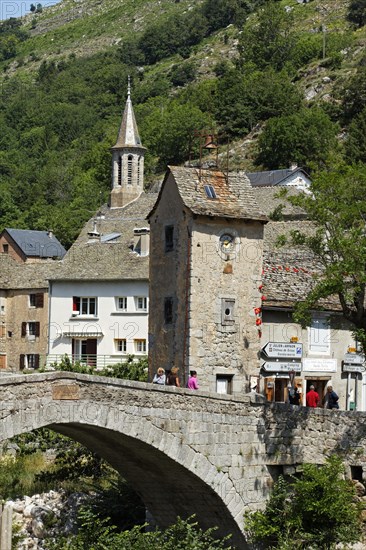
149 167 267 393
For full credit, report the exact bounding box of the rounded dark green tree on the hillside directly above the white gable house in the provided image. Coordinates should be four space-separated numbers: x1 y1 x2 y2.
256 107 337 169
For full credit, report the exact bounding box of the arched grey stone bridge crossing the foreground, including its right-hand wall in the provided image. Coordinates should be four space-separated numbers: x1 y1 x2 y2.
0 372 366 549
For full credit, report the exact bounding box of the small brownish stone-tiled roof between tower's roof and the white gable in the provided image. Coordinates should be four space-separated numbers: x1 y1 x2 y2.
253 187 306 219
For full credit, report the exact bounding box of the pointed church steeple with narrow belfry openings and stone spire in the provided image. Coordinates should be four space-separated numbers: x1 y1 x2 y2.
110 77 145 208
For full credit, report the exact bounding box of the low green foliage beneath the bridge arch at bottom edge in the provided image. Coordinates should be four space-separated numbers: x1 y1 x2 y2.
47 507 230 550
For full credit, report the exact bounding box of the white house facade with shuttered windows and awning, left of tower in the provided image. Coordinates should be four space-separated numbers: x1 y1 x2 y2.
48 280 149 368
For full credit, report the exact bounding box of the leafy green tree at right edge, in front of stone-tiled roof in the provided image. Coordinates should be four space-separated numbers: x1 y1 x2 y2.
284 164 366 351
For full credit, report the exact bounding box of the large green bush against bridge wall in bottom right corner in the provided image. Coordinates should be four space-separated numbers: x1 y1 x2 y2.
245 456 361 550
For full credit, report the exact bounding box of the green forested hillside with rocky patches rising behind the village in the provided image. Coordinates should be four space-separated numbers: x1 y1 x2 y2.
0 0 366 246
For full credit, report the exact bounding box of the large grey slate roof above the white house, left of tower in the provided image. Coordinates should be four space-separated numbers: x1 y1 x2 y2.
53 193 157 281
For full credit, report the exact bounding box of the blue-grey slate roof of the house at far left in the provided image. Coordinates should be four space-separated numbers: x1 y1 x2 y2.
4 228 66 258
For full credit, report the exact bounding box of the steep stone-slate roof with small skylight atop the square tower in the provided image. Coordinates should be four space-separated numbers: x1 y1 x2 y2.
150 166 267 222
